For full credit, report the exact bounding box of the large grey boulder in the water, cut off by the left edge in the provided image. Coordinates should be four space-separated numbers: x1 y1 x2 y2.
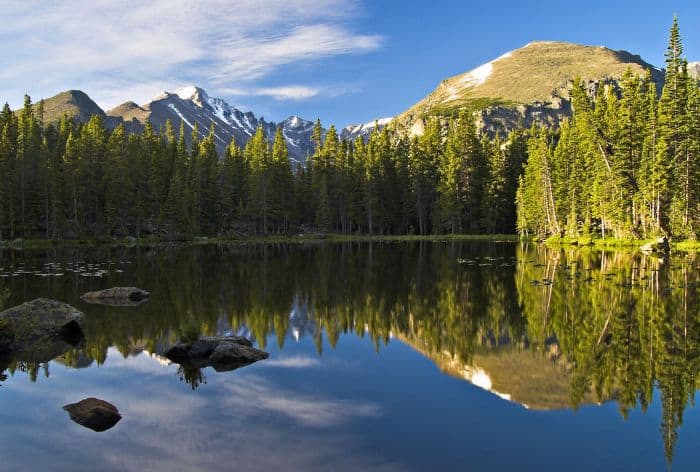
0 298 85 362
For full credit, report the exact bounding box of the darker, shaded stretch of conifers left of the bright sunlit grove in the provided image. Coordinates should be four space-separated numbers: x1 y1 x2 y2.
0 97 526 239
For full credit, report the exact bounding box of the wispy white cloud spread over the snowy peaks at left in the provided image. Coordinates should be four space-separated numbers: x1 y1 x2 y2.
0 0 383 106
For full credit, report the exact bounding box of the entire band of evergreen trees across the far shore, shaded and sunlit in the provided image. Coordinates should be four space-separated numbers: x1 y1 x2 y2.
0 20 700 240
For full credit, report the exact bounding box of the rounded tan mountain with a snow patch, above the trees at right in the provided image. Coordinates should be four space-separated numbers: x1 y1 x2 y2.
396 41 663 134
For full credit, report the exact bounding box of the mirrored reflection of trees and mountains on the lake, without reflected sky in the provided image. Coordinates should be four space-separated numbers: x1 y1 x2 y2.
0 242 700 466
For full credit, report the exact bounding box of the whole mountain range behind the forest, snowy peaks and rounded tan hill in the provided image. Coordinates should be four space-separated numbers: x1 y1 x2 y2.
21 41 700 163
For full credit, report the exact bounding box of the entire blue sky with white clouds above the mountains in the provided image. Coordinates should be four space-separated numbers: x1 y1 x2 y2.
0 0 700 126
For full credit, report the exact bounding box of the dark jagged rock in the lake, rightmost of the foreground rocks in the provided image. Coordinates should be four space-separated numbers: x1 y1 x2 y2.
164 336 269 372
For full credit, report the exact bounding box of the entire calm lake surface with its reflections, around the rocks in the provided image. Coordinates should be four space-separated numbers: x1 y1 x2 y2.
0 242 700 471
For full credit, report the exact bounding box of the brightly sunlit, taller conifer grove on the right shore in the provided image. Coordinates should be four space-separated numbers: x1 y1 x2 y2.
517 19 700 239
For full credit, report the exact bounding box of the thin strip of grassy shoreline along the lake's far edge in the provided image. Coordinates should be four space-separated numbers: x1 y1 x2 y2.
0 233 700 252
